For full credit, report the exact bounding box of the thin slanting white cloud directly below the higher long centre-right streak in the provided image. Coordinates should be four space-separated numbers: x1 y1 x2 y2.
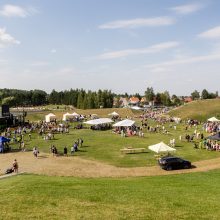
96 41 179 60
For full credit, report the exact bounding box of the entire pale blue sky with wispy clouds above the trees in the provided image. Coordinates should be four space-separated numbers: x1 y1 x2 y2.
0 0 220 95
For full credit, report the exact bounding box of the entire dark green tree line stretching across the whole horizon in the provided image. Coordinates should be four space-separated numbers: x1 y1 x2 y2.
0 87 218 109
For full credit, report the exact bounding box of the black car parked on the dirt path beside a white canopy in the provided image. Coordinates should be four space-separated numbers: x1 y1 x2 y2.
158 157 192 170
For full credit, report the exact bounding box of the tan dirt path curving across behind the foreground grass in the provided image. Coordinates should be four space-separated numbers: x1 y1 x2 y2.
0 152 220 177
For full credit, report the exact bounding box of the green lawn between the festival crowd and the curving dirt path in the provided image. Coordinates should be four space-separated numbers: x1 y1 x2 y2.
12 122 220 167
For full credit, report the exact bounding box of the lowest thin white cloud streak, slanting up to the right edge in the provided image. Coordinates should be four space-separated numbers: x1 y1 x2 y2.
145 53 220 71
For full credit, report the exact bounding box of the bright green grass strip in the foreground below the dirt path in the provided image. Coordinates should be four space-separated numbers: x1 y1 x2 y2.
0 170 220 220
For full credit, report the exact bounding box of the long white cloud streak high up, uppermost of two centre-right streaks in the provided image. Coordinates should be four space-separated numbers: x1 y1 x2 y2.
99 16 175 29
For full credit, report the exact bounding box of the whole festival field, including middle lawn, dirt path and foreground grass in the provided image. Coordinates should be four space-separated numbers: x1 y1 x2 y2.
0 101 220 220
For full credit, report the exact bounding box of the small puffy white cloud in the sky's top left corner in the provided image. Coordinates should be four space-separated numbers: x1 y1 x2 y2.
0 4 38 18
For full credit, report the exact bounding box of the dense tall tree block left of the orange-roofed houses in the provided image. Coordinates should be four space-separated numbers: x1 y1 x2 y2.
0 89 114 109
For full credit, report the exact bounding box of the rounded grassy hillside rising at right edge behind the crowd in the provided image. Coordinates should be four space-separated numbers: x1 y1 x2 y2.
169 99 220 121
